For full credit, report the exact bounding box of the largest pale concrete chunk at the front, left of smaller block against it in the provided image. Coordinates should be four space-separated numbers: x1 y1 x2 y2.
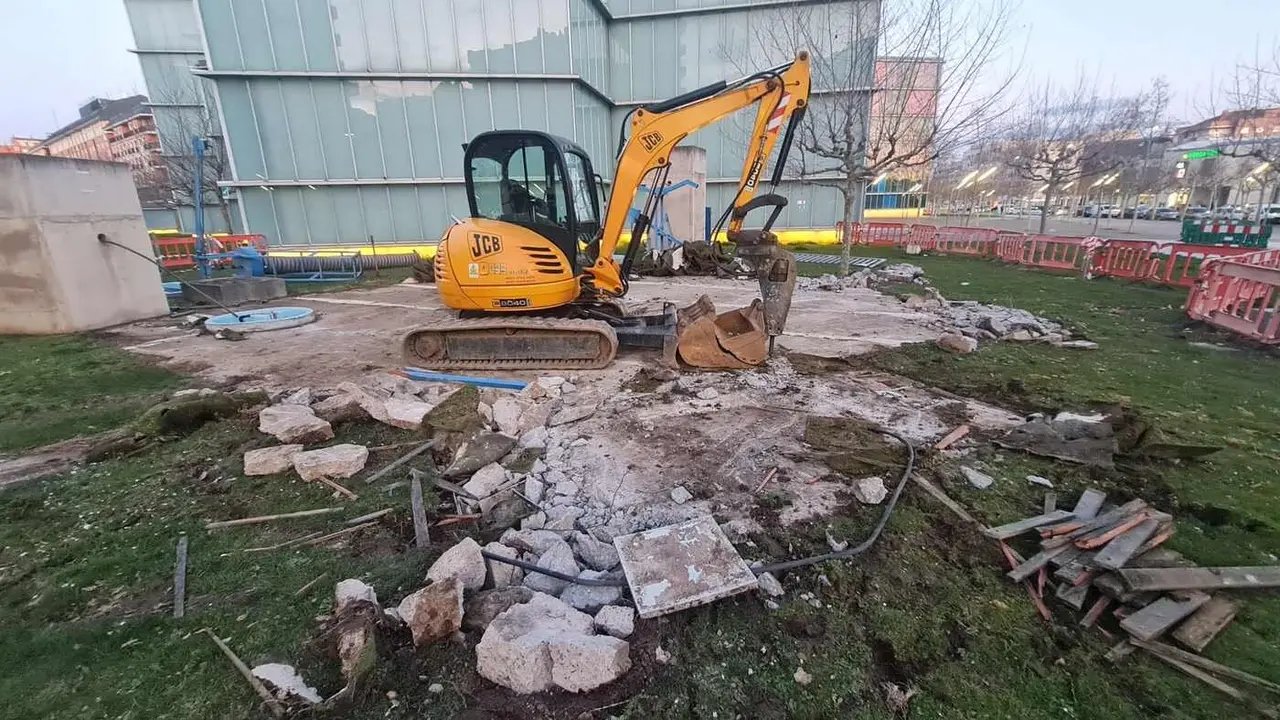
476 593 593 693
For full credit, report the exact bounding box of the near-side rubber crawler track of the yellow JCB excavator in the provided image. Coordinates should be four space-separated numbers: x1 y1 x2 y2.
401 318 618 370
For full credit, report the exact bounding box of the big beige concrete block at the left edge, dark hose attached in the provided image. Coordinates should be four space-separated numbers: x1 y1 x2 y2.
0 155 169 334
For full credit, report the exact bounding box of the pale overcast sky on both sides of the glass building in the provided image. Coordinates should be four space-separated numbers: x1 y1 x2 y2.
0 0 1280 142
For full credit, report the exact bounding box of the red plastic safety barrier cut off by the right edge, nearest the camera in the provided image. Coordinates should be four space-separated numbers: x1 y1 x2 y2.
1187 250 1280 345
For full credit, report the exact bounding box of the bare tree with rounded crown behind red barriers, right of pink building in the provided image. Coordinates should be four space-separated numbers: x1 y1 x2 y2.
1001 76 1151 233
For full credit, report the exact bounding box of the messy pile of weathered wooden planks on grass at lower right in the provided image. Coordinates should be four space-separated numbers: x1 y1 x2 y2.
983 489 1280 716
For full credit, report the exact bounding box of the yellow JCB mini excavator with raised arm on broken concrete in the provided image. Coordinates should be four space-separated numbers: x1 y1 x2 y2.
404 51 809 370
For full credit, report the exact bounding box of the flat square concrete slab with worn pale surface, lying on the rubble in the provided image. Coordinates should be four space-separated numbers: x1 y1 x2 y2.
613 515 756 619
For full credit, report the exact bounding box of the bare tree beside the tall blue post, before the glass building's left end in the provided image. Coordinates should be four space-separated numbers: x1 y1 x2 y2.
151 76 233 228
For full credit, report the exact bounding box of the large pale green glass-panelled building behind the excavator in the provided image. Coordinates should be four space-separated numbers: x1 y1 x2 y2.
124 0 878 246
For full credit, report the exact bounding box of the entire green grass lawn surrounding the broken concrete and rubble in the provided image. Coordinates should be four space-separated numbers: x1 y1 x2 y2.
0 251 1280 720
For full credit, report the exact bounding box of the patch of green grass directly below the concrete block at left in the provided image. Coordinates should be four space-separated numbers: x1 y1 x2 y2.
0 336 184 452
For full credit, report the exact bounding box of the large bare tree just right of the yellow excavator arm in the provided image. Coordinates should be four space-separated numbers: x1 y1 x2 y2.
724 0 1015 274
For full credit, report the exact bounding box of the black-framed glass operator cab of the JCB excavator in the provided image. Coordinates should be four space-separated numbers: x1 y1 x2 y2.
463 129 600 274
